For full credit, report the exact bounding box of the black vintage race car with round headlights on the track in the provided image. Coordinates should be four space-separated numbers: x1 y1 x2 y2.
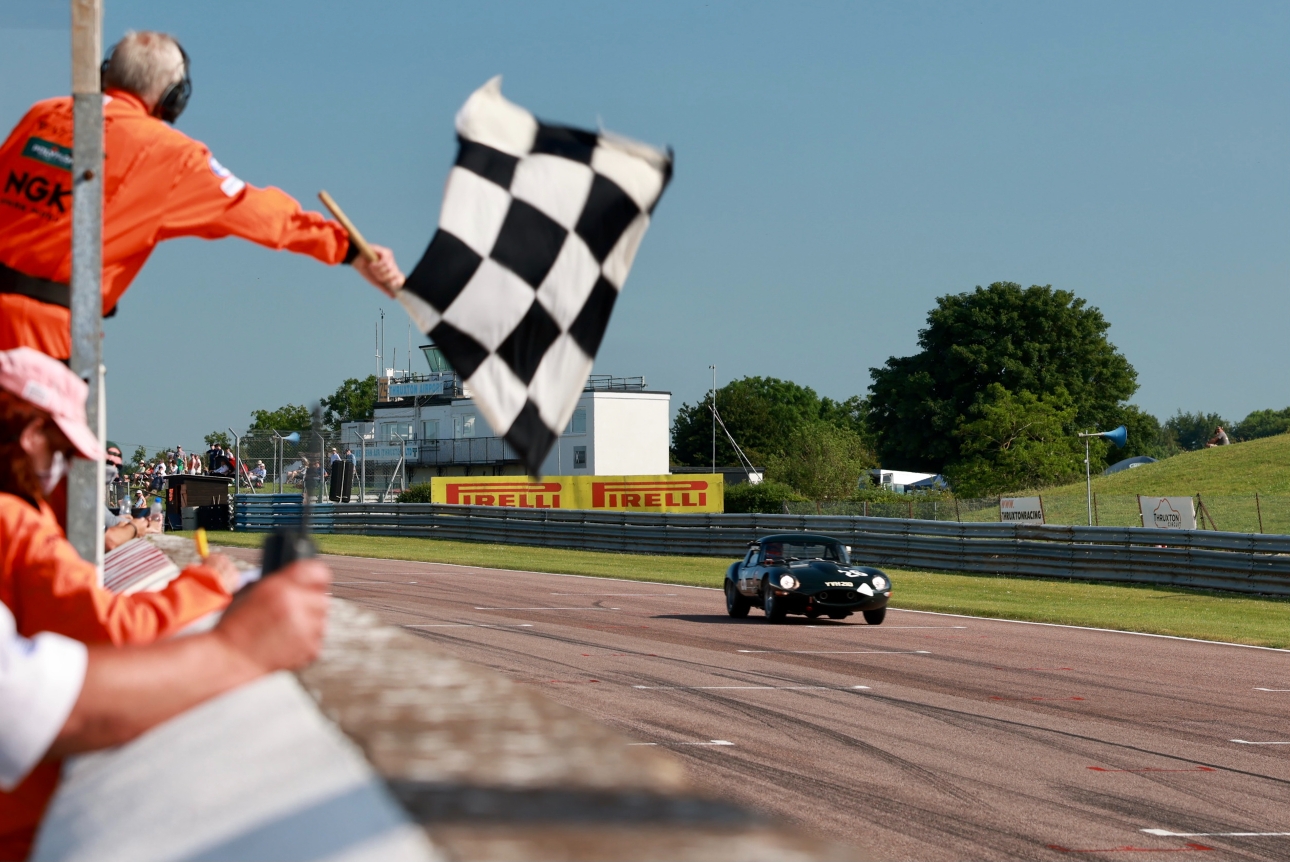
725 533 891 626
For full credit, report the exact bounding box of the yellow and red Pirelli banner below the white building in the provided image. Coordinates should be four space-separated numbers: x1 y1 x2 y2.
430 474 725 512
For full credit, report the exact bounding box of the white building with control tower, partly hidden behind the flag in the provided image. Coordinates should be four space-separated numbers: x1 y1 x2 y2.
342 346 672 483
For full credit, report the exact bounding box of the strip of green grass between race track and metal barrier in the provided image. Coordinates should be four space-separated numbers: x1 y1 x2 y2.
196 533 1290 648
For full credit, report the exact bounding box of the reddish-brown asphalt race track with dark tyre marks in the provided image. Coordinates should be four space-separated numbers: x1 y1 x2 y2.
274 555 1290 859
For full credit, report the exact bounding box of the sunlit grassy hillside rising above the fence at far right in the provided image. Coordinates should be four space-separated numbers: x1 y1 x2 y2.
1044 434 1290 497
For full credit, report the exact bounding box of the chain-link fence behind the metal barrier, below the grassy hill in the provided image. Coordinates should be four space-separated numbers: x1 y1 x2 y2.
784 494 1290 536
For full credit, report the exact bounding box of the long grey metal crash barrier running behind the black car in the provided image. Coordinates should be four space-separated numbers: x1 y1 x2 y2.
235 494 1290 596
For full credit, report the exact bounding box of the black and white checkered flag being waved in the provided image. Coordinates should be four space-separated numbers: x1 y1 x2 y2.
399 77 672 475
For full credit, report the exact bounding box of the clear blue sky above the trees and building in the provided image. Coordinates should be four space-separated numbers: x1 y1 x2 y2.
0 0 1290 456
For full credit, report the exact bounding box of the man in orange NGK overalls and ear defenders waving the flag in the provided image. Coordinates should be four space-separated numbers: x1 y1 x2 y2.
0 31 402 359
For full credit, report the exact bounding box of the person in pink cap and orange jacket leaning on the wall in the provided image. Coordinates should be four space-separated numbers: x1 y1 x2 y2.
0 347 246 858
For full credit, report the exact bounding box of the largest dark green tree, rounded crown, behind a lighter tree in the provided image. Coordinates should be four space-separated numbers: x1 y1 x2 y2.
867 281 1138 472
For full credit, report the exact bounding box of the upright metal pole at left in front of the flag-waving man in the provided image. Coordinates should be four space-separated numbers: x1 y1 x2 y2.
67 0 107 572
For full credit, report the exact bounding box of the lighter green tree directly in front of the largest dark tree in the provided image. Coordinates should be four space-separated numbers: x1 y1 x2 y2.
947 383 1084 497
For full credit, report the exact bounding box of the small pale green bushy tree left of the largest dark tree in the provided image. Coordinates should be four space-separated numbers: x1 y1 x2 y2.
768 419 877 511
